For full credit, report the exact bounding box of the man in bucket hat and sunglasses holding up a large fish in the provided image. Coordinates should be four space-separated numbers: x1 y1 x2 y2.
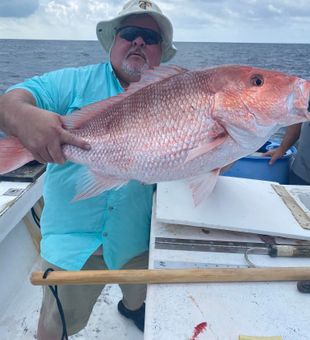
0 0 176 340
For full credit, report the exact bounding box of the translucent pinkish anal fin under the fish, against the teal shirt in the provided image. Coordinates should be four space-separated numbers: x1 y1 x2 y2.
73 169 128 201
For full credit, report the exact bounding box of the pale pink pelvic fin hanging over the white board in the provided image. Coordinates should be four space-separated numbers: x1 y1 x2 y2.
188 169 220 207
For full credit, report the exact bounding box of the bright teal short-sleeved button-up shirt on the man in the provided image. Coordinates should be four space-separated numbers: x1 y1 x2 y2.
9 63 154 270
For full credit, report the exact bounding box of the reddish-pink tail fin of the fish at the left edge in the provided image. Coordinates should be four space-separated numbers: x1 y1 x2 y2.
0 137 34 174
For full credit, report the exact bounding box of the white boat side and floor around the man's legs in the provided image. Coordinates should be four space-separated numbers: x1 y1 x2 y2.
0 178 143 340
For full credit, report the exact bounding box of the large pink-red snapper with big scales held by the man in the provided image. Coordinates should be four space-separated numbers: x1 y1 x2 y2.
0 65 310 204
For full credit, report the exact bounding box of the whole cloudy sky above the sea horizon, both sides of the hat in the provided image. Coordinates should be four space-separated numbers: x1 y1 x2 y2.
0 0 310 44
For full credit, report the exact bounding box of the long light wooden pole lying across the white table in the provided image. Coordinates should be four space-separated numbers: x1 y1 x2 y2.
31 267 310 285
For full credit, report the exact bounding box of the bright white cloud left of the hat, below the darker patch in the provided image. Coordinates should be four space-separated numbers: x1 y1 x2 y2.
0 0 123 40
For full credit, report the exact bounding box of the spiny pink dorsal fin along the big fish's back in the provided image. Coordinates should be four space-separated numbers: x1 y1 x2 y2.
61 65 188 129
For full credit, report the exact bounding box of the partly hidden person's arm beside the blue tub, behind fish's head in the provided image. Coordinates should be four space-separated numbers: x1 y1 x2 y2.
263 124 301 165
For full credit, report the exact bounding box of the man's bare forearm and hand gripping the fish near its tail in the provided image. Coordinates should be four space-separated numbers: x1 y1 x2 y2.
0 89 90 163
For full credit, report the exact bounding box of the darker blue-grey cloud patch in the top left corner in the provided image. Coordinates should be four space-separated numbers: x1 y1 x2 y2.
0 0 39 18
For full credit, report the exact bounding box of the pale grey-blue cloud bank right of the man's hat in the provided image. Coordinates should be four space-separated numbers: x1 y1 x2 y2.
159 0 310 43
